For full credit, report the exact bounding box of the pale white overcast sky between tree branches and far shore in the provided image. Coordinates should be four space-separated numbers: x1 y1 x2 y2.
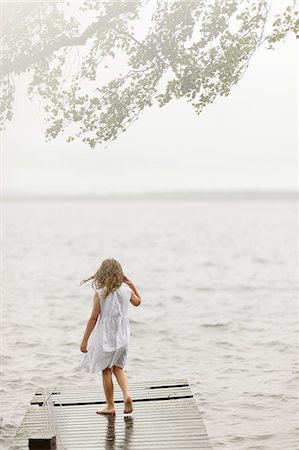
2 28 298 194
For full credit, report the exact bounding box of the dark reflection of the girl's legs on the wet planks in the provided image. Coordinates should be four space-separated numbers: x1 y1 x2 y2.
105 414 134 450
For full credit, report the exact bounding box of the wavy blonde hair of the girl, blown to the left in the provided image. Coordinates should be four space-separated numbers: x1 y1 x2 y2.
80 258 124 298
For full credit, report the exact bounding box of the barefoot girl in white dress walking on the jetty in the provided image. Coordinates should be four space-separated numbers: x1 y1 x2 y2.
80 259 141 414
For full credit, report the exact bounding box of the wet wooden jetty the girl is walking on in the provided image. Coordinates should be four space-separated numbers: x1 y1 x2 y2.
10 379 212 450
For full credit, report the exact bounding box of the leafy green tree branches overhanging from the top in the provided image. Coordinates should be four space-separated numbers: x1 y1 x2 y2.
0 0 299 148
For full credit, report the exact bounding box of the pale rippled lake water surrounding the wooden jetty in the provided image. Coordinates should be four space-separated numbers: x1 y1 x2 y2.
0 199 298 450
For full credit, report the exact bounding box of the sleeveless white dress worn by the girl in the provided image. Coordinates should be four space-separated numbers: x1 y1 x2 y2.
81 282 132 373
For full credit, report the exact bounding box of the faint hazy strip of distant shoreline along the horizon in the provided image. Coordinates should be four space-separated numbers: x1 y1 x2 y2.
2 190 298 202
